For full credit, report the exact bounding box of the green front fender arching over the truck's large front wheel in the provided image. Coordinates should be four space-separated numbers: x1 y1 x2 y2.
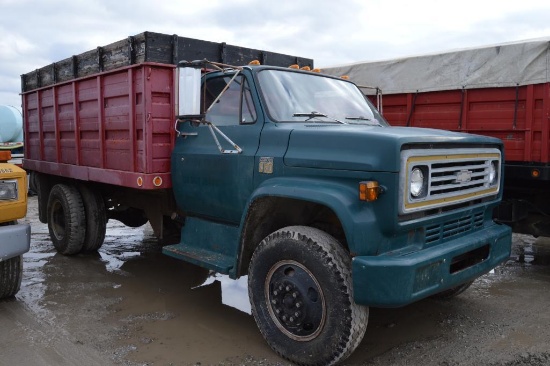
241 177 380 255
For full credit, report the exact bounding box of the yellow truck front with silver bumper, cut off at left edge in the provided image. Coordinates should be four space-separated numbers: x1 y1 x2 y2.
0 151 31 299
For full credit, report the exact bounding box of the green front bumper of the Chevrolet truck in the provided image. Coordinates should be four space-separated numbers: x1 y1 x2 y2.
352 225 512 307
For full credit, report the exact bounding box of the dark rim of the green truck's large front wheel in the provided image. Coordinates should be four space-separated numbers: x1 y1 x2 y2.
264 260 326 341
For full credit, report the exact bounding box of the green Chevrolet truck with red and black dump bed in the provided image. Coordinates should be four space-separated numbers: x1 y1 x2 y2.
22 32 511 365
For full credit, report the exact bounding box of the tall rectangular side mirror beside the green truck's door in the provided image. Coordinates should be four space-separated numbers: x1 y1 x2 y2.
176 61 203 120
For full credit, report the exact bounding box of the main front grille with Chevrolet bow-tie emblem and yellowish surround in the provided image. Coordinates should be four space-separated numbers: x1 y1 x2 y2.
399 148 501 214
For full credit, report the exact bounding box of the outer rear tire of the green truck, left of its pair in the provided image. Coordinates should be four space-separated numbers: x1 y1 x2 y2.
48 184 86 255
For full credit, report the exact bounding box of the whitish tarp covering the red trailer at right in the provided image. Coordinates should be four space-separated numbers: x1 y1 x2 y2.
322 38 550 94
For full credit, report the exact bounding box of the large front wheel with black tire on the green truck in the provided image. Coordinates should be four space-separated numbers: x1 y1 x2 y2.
248 226 368 365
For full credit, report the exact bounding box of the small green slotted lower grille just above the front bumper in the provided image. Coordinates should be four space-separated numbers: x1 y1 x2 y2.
426 212 483 245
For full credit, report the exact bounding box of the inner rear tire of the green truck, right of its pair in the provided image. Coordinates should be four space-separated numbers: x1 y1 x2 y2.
78 185 107 252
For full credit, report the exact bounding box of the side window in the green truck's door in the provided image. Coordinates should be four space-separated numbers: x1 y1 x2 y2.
202 76 256 126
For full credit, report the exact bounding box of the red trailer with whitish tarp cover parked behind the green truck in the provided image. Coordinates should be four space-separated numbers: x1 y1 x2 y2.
324 39 550 236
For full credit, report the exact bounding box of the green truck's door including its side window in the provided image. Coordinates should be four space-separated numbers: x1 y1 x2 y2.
172 74 263 224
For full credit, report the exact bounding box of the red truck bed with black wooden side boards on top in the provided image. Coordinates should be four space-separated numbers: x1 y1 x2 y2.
21 32 313 189
